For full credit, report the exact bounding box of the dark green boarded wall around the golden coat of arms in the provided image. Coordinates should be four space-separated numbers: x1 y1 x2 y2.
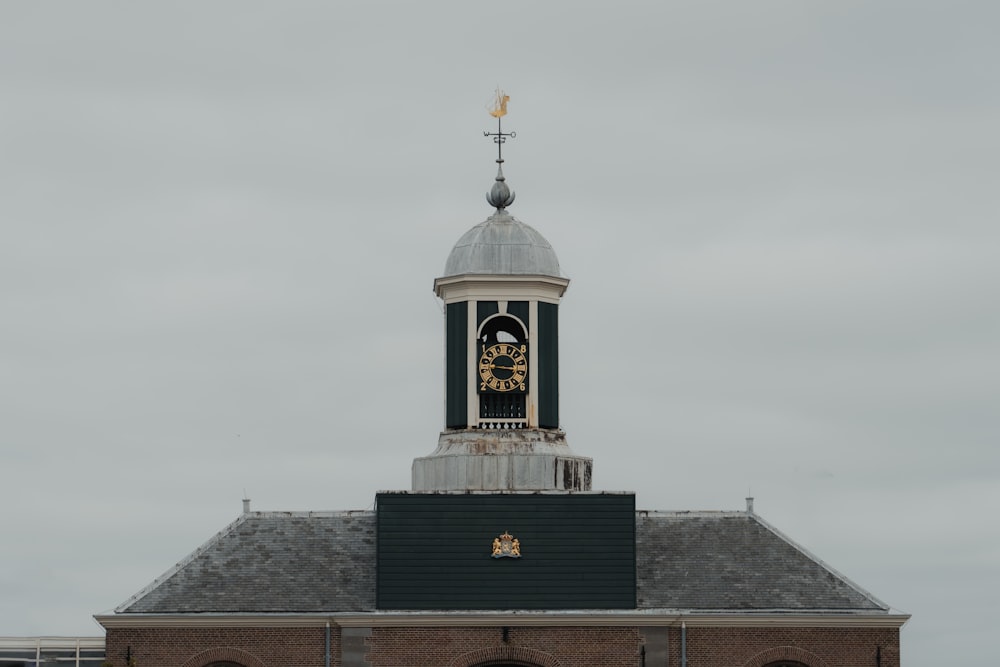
376 493 636 610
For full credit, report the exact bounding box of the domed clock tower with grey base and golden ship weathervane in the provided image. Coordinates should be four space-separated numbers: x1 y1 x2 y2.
413 100 592 492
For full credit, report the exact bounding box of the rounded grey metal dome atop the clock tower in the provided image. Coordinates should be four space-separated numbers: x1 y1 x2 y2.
443 209 562 278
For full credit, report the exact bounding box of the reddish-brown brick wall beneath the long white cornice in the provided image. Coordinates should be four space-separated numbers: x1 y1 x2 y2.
107 627 900 667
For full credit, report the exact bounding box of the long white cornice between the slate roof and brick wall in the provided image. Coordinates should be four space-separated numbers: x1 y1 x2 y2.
94 610 910 629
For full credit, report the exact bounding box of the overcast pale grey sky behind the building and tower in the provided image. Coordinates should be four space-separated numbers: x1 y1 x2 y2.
0 0 1000 667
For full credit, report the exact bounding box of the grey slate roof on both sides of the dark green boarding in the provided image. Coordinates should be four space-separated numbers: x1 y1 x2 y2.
115 511 889 614
